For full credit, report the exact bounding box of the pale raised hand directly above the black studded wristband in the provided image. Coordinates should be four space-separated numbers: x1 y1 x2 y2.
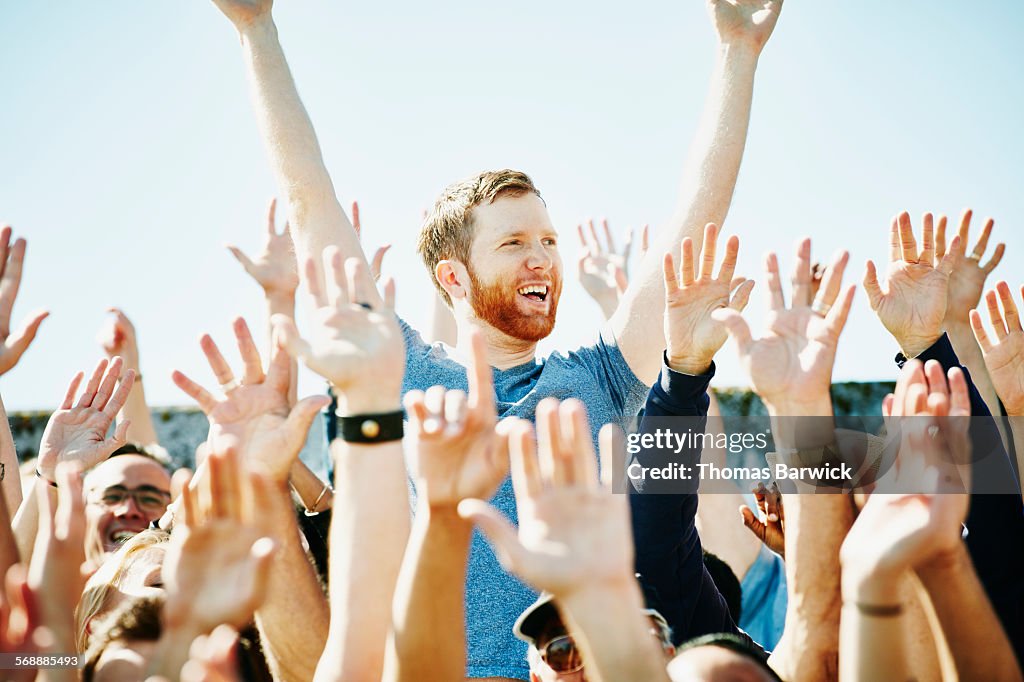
273 247 406 414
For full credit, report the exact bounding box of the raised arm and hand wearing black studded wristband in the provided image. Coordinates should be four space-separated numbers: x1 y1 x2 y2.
274 247 409 680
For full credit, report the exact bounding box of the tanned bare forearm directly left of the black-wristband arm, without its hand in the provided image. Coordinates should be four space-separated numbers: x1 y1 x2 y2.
256 477 330 682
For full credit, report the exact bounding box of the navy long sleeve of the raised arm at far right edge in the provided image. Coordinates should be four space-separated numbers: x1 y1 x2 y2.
896 335 1024 662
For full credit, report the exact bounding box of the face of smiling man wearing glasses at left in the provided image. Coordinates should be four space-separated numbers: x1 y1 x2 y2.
83 446 171 566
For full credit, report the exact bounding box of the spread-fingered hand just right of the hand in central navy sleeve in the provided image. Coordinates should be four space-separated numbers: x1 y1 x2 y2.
712 240 855 415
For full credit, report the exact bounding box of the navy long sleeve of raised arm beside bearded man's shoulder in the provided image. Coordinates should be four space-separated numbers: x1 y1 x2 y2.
630 358 741 643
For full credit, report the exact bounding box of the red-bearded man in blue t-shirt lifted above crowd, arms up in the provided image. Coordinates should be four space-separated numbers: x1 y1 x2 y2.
214 0 782 680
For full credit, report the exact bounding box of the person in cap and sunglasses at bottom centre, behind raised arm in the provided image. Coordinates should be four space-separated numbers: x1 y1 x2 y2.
512 576 676 682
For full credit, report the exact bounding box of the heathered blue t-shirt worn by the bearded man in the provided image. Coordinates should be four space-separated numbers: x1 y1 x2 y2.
399 321 647 680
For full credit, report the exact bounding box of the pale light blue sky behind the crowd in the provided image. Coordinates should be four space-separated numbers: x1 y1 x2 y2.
0 0 1024 409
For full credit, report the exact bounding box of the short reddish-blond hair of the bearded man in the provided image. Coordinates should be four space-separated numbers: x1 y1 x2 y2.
417 168 541 307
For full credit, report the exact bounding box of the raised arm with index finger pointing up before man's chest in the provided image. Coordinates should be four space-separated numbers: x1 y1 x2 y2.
384 332 508 681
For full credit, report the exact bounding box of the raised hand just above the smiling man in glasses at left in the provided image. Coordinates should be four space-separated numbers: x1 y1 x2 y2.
38 357 135 481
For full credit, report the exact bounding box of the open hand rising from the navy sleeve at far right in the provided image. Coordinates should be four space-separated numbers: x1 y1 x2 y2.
864 211 961 357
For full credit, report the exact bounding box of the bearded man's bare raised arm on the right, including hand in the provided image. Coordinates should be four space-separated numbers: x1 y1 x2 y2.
611 0 782 384
